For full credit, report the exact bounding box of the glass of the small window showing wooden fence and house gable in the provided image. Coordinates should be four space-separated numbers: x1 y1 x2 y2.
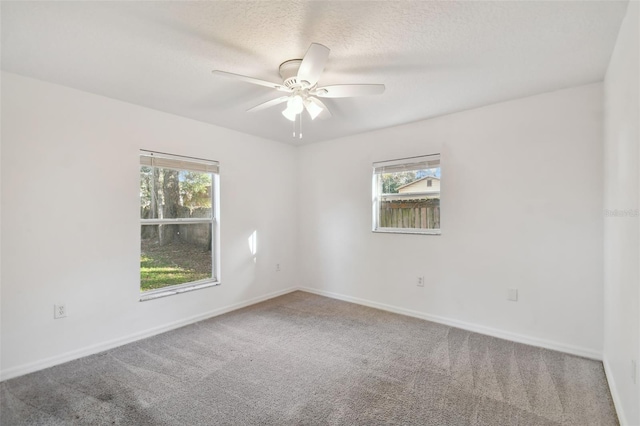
378 167 440 229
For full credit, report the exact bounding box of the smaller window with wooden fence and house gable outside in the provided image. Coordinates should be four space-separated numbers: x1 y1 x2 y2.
373 154 442 234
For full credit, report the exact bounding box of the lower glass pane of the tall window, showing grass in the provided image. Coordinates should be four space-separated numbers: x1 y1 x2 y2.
140 223 213 292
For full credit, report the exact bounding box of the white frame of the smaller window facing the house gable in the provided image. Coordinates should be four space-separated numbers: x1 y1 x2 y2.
371 154 442 235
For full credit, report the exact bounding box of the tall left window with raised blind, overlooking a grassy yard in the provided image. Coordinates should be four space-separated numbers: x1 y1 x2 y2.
140 151 220 300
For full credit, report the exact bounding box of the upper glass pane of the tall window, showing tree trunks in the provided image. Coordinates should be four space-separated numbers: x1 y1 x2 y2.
140 166 212 219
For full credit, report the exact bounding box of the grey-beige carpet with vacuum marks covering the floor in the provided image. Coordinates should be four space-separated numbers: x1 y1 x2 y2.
0 292 617 426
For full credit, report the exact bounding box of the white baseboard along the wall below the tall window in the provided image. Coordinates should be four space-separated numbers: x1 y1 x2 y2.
0 287 299 382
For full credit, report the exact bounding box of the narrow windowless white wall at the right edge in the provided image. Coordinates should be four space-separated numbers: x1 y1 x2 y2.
604 2 640 425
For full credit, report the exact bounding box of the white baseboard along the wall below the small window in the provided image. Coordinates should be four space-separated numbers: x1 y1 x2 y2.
299 287 602 361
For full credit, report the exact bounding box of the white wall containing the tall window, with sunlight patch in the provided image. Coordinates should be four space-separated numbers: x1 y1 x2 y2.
1 73 297 379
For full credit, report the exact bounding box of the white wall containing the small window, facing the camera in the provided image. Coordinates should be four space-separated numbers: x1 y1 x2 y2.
298 83 603 358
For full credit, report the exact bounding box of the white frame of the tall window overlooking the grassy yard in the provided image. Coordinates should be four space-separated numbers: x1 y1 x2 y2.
138 150 221 302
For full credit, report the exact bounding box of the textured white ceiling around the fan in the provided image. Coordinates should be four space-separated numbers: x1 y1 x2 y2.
0 1 627 144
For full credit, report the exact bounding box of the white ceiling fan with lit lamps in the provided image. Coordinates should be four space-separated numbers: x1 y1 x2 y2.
213 43 384 123
